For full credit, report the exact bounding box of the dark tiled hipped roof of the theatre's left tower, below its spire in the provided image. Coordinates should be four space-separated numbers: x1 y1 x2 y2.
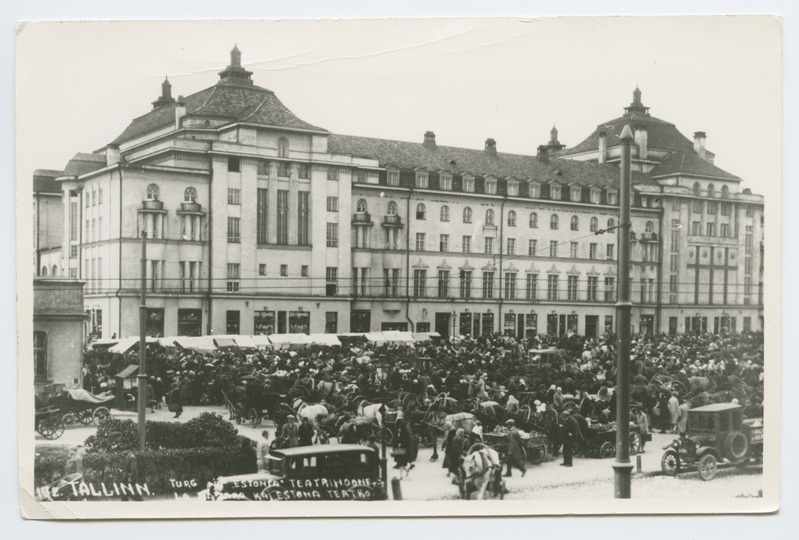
113 82 326 144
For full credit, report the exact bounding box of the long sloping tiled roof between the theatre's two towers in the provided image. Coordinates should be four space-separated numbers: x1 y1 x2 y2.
328 134 654 188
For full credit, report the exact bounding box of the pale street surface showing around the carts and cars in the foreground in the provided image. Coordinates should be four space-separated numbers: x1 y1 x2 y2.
36 407 762 500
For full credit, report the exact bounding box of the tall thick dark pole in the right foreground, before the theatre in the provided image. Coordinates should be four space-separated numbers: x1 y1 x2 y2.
613 125 633 499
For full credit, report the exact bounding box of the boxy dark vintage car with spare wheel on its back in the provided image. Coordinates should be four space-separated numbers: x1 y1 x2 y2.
660 403 763 480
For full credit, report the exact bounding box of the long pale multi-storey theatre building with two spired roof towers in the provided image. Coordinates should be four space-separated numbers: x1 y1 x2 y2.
32 48 763 337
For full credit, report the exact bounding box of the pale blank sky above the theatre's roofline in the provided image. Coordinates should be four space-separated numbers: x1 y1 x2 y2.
17 16 781 193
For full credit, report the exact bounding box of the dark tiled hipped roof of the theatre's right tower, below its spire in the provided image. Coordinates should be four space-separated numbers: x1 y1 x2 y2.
558 113 693 156
